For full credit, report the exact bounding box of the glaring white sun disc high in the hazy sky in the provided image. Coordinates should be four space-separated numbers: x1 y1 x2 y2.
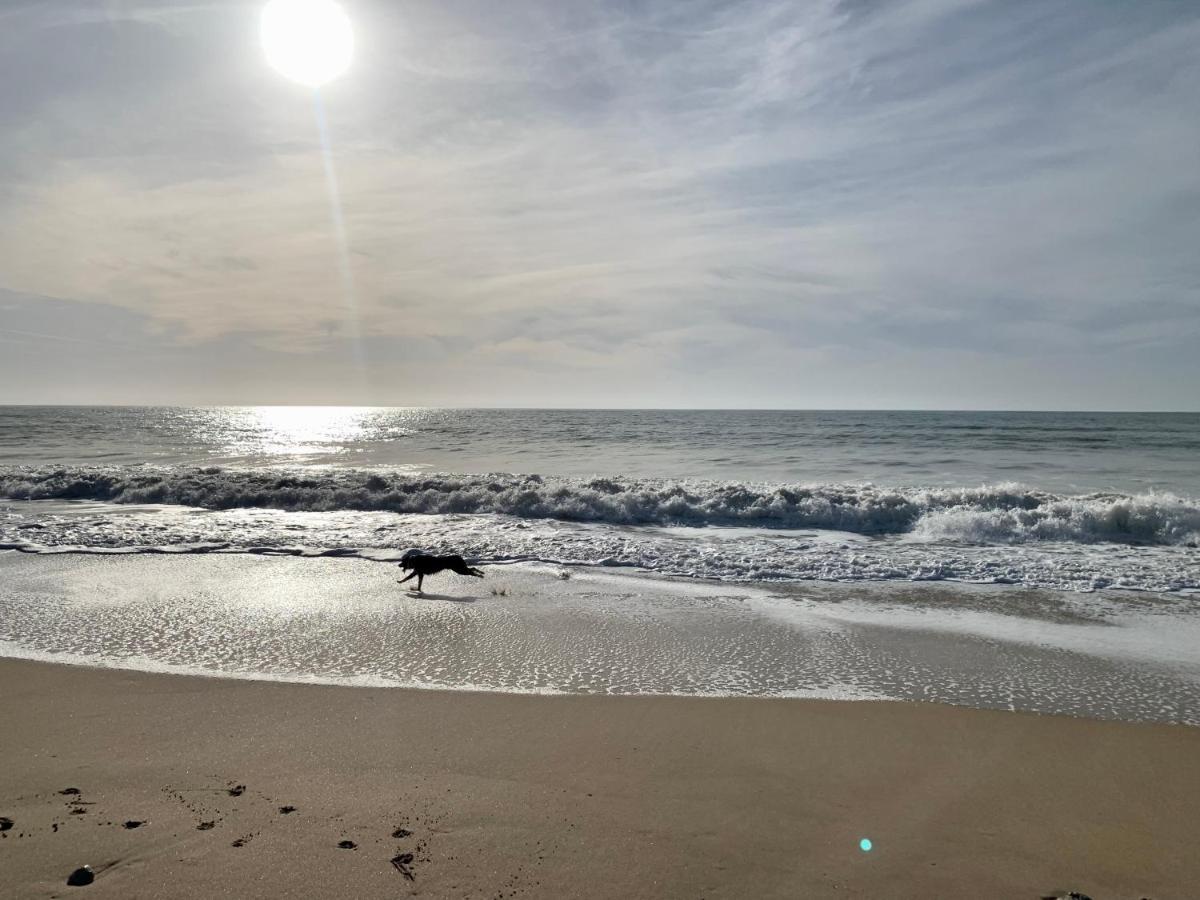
262 0 354 88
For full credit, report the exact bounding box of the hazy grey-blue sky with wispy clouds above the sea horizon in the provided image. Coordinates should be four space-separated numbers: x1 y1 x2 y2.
0 0 1200 410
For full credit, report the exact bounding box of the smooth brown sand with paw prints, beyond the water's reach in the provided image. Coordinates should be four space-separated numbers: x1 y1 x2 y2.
0 660 1200 900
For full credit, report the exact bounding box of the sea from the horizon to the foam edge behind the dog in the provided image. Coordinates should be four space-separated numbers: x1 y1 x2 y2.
0 407 1200 594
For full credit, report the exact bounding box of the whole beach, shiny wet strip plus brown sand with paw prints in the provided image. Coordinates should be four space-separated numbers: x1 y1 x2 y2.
0 553 1200 900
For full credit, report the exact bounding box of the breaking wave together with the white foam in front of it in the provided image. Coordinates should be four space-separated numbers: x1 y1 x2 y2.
0 467 1200 593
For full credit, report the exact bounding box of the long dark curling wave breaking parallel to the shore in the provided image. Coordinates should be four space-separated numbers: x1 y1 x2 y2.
0 467 1200 546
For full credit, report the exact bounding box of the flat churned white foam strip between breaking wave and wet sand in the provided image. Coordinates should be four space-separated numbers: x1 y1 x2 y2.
0 502 1200 593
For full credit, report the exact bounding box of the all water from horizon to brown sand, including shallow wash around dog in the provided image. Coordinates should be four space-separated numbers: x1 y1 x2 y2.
0 407 1200 725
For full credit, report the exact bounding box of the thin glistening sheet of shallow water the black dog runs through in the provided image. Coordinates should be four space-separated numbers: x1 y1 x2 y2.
0 553 1200 725
